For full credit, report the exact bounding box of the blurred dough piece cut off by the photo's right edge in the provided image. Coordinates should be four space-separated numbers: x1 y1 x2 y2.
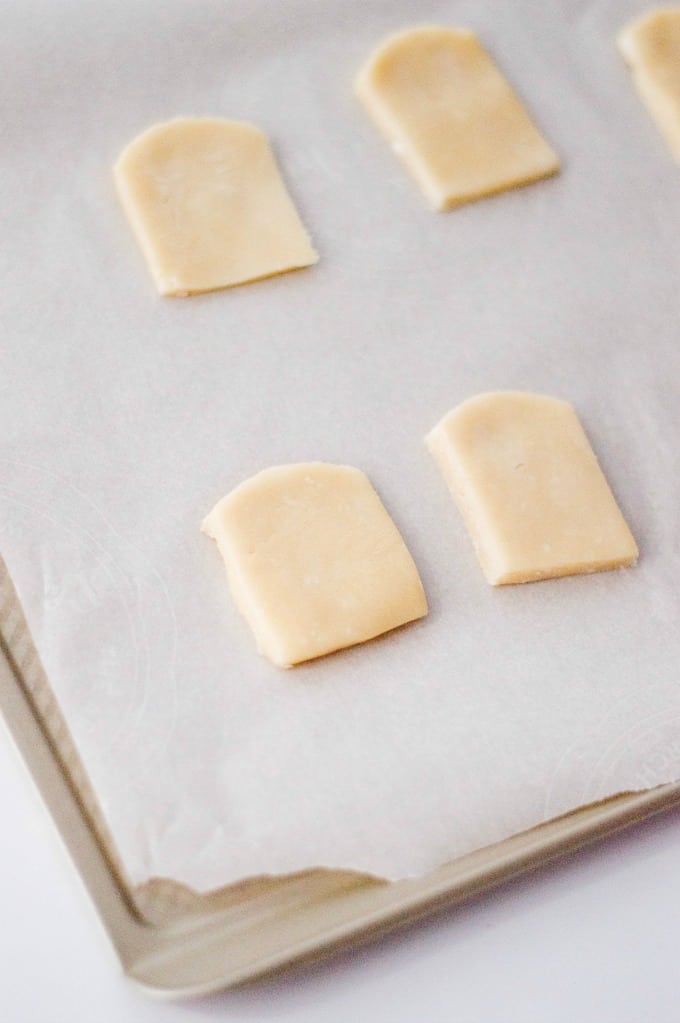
619 7 680 163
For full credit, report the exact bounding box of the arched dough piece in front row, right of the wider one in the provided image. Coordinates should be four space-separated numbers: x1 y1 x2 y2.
425 391 638 586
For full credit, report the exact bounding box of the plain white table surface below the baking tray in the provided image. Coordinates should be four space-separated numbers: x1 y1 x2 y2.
0 729 680 1023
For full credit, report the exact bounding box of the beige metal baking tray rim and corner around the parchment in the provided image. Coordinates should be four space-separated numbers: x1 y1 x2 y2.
0 559 680 997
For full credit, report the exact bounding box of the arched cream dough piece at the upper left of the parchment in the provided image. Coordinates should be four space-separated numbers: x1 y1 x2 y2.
114 118 318 296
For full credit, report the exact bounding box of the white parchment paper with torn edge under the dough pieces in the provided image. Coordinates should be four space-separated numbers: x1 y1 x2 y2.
0 2 680 890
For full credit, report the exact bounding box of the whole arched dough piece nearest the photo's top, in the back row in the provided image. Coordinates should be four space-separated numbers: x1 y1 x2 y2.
356 27 559 210
